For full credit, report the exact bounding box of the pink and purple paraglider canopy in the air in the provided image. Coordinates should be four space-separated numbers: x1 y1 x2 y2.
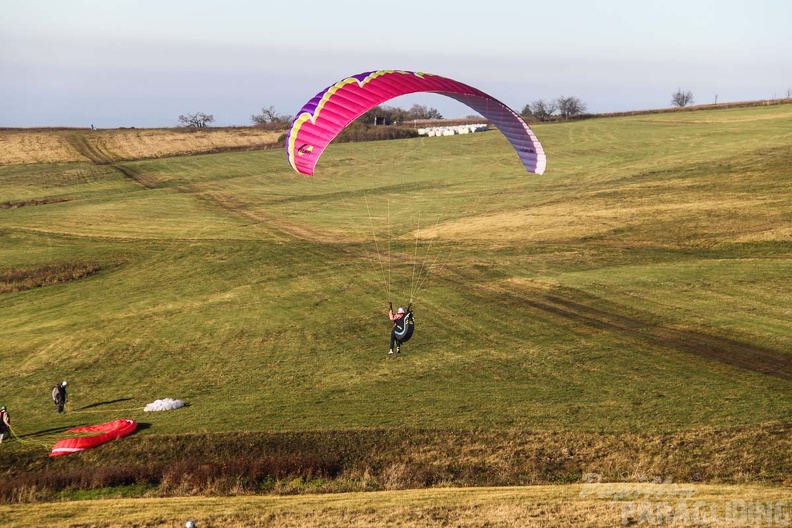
286 70 547 176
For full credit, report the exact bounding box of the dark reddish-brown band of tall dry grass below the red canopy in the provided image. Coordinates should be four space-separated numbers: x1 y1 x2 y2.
0 423 790 503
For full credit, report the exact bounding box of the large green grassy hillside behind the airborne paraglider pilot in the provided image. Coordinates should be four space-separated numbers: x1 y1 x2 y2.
0 105 792 516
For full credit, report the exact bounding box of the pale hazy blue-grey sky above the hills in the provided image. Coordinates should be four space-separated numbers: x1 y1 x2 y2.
0 0 792 128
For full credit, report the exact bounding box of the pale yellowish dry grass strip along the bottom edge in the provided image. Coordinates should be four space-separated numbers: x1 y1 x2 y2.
0 484 792 528
